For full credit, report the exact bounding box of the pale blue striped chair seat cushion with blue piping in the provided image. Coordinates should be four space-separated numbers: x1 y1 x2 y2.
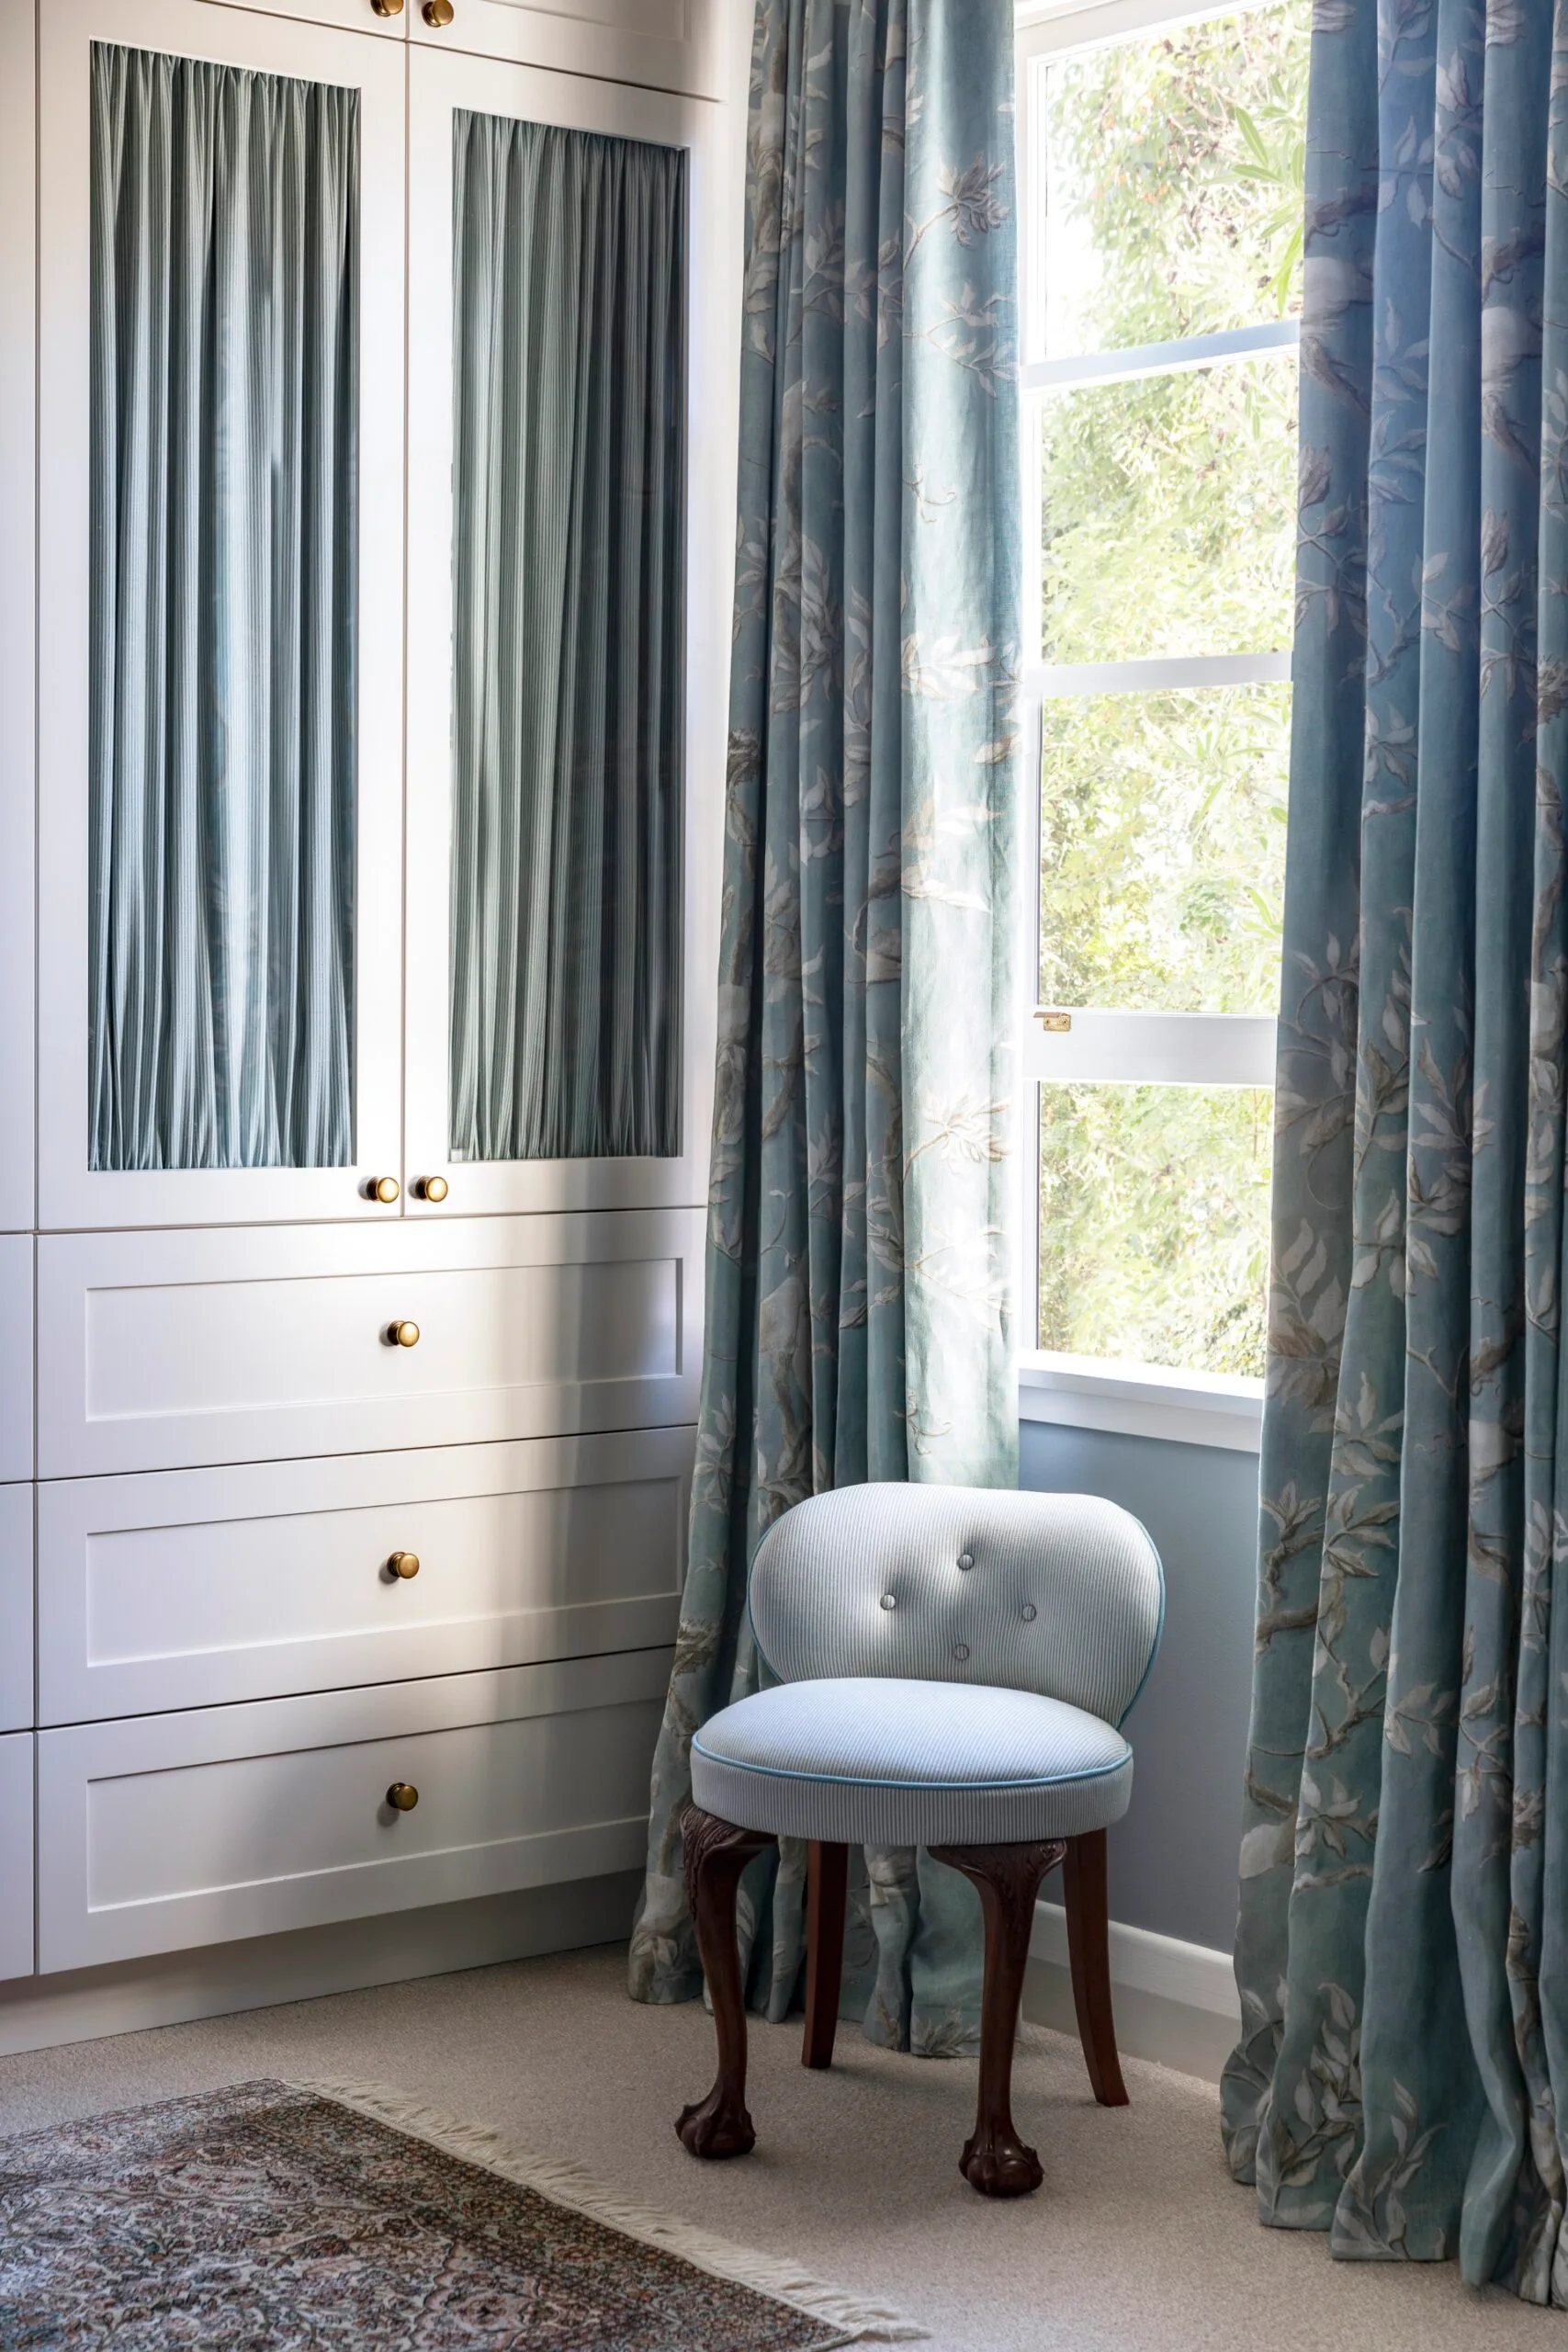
691 1675 1134 1847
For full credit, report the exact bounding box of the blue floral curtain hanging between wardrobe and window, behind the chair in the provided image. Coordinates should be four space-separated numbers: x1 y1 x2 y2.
630 0 1018 2053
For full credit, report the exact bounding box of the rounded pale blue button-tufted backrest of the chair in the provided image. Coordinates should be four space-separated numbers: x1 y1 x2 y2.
750 1484 1166 1724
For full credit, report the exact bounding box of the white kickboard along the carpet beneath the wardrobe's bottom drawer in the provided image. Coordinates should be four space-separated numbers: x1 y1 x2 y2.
0 1870 642 2055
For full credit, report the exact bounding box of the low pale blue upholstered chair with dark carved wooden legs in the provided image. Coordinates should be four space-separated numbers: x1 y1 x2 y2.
677 1487 1164 2197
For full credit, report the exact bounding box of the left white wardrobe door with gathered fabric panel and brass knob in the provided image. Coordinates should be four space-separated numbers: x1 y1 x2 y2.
40 0 404 1226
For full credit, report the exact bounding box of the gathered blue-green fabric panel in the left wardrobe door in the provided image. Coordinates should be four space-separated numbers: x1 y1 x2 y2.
89 45 360 1169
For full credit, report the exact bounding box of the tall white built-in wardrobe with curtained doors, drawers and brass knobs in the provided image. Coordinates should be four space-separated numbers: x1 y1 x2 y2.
0 0 745 2008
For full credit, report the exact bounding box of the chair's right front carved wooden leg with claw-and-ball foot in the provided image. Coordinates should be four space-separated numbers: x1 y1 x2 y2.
931 1837 1063 2197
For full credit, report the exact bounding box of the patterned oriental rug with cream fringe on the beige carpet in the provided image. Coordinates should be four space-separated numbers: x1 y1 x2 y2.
0 2082 921 2352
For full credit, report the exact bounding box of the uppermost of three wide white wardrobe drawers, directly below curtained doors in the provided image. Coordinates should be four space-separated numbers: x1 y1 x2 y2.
38 1209 703 1477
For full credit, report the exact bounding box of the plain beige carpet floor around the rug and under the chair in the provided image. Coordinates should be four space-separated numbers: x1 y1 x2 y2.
0 1952 1563 2352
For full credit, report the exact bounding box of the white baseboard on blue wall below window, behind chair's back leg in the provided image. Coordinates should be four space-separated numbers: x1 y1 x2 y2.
1022 1903 1241 2082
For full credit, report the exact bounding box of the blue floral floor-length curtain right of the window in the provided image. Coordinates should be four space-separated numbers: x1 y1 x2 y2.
1224 0 1568 2302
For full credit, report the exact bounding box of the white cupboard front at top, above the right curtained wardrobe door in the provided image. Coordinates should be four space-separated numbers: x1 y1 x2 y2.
409 0 724 99
